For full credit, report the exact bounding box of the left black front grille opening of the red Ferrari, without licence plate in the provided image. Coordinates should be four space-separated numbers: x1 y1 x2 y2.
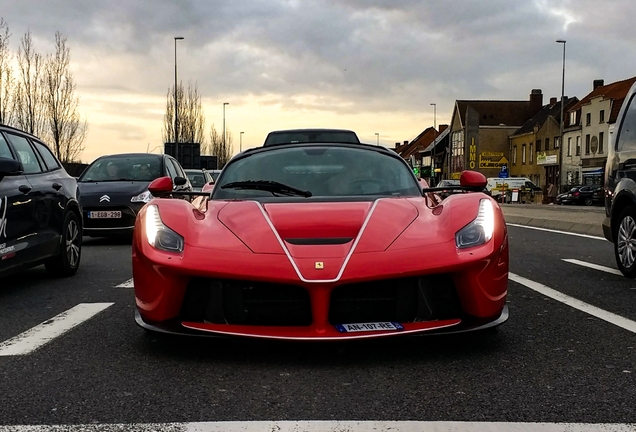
181 279 312 326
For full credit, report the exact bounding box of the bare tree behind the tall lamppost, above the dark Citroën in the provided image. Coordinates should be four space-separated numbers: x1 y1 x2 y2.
162 82 207 154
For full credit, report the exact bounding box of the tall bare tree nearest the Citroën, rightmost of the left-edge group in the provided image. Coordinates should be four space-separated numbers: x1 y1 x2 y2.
42 32 87 162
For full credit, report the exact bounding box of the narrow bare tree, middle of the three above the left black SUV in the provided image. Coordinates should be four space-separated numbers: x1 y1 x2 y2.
13 31 45 136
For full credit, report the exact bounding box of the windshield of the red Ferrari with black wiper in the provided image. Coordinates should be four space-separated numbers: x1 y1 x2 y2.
213 146 420 199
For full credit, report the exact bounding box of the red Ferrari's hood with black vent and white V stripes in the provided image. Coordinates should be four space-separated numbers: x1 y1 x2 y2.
218 199 418 258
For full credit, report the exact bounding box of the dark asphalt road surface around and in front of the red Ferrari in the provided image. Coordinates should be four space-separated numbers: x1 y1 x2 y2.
0 216 636 431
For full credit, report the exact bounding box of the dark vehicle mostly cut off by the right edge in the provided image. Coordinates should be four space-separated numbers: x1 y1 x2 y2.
603 80 636 278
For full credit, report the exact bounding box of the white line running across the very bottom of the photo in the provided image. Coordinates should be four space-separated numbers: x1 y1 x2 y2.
0 421 636 432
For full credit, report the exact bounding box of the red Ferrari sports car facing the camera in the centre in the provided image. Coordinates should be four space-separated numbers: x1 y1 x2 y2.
133 143 508 340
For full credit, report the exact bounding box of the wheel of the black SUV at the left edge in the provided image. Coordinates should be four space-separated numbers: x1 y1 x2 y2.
44 211 82 277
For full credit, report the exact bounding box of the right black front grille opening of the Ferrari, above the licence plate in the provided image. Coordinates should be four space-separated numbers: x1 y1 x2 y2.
329 275 461 324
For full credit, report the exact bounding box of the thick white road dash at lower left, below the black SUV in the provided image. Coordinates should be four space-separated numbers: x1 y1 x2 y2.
0 303 114 357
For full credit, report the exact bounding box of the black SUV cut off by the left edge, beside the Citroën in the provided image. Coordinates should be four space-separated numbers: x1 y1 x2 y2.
0 125 82 277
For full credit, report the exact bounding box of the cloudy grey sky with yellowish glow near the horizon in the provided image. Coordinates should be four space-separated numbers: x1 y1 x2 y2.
0 0 636 162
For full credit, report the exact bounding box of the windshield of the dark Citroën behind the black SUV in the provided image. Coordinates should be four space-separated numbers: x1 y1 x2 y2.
79 155 162 182
